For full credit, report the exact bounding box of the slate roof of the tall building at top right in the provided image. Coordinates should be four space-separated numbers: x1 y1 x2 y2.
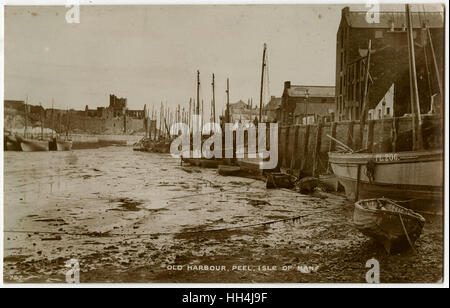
343 8 444 29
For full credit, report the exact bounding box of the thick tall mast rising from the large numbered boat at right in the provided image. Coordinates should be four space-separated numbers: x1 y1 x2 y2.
405 4 423 151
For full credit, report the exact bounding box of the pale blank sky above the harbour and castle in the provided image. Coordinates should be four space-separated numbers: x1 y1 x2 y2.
4 5 444 115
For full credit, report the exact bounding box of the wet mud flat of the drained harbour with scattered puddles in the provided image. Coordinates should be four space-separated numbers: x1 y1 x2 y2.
3 147 443 283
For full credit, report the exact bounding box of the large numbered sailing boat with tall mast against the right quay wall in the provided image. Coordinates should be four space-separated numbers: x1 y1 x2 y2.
328 5 443 212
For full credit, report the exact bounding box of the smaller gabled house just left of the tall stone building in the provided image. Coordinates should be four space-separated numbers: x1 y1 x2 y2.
280 81 336 125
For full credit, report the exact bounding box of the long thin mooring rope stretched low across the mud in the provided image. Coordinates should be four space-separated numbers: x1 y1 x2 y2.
3 208 340 237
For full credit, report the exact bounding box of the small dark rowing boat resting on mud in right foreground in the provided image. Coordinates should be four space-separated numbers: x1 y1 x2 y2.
353 198 425 253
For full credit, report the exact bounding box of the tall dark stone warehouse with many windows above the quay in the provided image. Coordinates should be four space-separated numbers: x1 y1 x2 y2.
335 7 445 121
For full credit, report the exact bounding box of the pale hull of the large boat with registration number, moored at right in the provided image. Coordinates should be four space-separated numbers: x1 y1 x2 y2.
329 151 443 209
